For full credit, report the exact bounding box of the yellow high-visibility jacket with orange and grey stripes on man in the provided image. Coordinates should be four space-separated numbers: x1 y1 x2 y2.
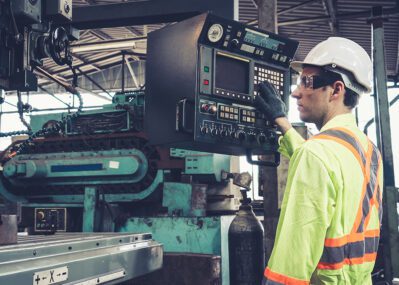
265 114 383 285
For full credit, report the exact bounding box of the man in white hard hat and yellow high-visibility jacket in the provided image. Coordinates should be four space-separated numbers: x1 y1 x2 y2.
256 37 382 285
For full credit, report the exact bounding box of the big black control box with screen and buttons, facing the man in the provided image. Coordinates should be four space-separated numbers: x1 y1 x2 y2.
144 13 298 155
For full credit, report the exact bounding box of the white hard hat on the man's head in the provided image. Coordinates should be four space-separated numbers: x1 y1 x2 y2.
291 37 373 94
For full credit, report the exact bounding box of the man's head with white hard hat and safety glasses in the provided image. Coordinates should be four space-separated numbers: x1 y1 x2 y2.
291 37 372 127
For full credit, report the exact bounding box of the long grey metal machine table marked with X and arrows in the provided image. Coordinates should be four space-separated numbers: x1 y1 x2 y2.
0 233 163 285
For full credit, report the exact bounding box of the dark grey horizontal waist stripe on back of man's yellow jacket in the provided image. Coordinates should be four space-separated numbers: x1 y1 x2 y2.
320 234 379 264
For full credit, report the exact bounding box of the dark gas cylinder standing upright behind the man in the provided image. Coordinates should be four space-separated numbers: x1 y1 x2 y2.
228 191 265 285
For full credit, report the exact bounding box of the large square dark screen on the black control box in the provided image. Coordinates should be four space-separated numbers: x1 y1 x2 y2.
215 53 249 94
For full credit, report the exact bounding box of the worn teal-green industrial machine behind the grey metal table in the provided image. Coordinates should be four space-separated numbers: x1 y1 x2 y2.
0 90 241 284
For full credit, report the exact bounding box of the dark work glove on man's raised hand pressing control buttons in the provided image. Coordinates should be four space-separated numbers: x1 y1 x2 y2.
255 81 287 121
